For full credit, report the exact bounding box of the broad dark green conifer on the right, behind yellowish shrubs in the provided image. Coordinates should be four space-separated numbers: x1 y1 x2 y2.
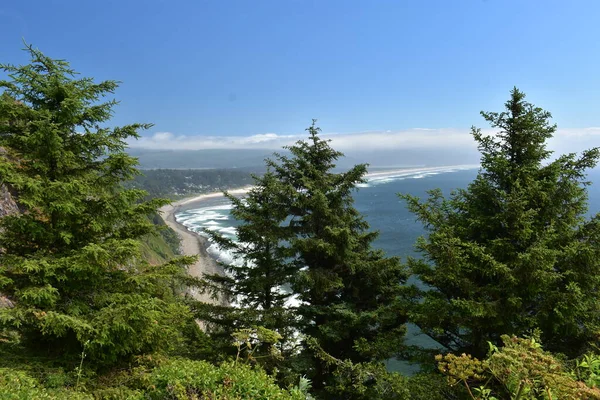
401 88 600 357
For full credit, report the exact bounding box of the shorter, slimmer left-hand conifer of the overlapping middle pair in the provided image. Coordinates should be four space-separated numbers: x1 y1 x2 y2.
196 171 295 368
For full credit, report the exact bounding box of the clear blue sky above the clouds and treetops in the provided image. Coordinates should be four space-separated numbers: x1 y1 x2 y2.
0 0 600 150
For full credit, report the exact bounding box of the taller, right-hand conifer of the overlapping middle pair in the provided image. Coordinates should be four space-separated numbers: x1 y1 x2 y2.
268 121 407 388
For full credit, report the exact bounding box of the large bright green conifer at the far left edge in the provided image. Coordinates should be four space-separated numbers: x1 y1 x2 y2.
0 47 190 363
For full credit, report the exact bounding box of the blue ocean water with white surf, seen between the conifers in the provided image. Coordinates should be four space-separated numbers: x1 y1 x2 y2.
175 166 600 373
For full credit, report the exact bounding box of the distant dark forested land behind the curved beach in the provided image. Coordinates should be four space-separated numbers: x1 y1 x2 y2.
126 168 259 198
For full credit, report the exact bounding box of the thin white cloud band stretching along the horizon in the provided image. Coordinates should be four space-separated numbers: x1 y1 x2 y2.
130 127 600 153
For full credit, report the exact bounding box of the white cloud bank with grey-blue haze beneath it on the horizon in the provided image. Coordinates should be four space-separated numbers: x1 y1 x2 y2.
124 128 600 168
